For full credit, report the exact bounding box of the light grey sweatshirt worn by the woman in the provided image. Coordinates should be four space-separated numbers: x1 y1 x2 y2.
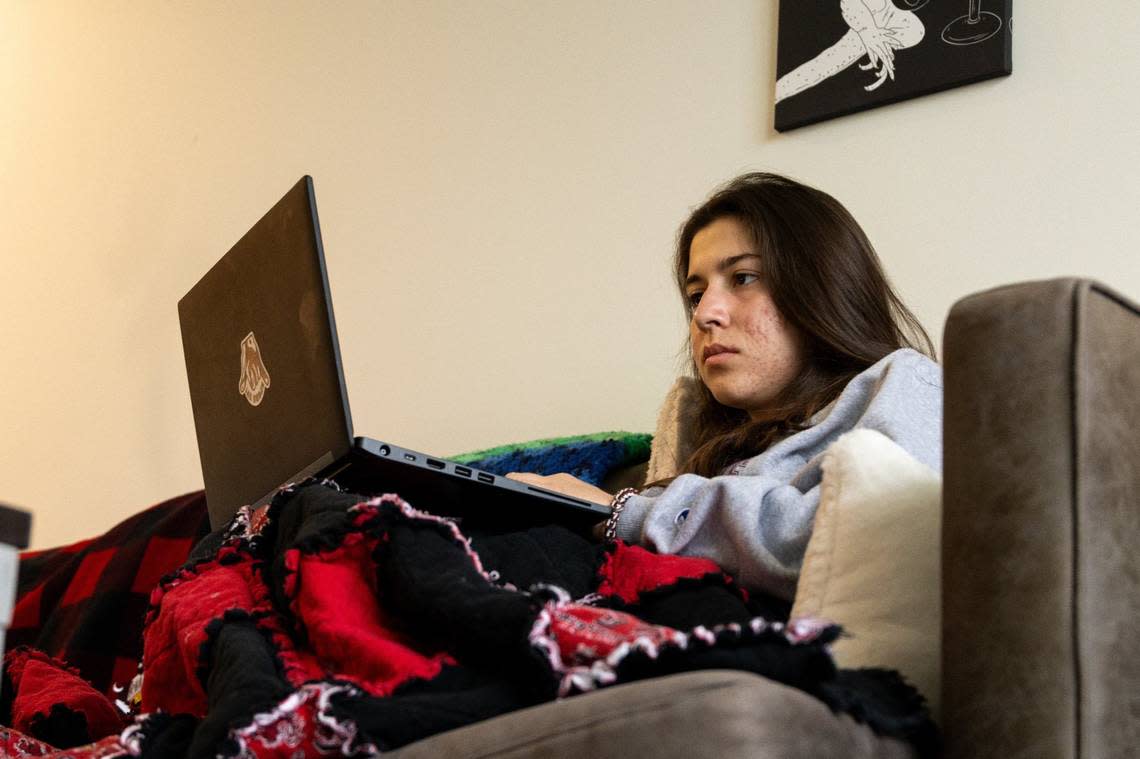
617 349 942 599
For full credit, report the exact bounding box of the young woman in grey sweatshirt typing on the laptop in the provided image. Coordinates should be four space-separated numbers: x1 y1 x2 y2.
512 173 942 599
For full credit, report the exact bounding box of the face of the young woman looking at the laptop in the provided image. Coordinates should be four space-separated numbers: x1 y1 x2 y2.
685 217 804 418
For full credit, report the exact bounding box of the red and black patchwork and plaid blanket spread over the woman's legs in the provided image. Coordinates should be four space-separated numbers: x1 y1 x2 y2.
0 483 933 758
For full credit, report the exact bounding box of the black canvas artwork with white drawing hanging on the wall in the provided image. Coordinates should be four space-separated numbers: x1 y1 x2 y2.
775 0 1013 131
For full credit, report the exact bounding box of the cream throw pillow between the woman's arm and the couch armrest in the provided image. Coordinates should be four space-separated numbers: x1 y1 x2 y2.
792 430 942 719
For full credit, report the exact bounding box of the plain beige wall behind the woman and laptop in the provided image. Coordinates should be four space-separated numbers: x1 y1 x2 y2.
0 0 1140 547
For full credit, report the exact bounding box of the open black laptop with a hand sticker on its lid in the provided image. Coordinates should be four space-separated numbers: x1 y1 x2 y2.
178 177 609 532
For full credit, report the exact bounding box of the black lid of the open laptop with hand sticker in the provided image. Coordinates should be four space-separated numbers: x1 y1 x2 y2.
178 177 352 524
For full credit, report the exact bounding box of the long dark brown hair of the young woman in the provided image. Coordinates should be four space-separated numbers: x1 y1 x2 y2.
654 173 934 484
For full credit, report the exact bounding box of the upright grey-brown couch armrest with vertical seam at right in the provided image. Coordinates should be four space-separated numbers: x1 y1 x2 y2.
943 279 1140 759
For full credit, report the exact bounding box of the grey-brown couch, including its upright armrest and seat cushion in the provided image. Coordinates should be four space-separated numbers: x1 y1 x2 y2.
394 279 1140 759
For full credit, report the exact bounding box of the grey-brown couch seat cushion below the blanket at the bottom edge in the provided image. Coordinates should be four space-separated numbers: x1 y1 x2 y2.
391 670 914 759
